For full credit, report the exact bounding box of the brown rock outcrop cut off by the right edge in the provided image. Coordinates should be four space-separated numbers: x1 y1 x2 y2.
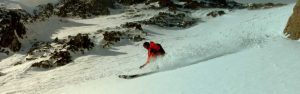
284 0 300 40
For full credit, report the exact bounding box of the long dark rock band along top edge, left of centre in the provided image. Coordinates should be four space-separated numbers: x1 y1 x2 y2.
33 0 110 18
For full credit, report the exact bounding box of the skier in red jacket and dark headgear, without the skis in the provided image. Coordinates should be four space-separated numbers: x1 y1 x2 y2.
140 41 165 69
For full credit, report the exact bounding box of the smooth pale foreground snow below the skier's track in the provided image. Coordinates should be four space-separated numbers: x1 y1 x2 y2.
52 40 300 94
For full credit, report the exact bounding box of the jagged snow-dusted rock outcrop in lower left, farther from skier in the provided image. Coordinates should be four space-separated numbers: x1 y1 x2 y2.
28 33 94 69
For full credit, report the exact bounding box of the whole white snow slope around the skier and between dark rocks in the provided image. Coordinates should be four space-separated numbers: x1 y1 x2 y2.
0 0 300 94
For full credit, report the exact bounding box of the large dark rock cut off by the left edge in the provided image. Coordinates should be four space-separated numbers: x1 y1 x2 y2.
0 9 27 52
